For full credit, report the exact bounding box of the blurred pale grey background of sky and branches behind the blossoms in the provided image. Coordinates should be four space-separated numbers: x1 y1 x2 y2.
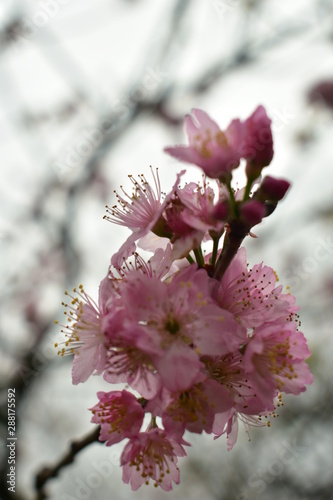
0 0 333 500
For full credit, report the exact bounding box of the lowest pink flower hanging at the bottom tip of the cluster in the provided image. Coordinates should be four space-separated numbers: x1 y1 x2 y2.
120 428 186 491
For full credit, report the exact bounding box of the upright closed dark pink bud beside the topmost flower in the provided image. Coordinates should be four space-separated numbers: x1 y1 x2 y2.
242 106 274 178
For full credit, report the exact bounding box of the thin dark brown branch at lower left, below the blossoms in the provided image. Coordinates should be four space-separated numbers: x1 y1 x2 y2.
35 426 101 500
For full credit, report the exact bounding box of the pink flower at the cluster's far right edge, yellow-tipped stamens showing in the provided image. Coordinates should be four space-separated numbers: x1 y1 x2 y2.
244 323 313 397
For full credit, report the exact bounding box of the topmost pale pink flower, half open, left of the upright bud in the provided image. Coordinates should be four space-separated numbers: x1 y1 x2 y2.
165 109 243 180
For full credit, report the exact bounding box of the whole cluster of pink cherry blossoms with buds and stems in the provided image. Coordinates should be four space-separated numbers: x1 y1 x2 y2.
56 106 313 491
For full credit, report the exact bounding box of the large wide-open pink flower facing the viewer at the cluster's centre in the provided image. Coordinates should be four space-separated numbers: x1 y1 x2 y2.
122 265 244 390
